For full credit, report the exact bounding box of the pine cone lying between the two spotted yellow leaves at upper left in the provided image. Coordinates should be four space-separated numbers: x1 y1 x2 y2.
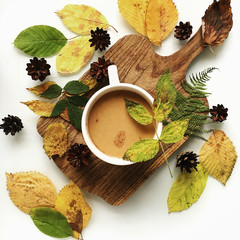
89 27 111 51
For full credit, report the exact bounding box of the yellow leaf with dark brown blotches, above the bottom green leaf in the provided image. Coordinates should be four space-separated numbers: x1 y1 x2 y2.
55 181 92 237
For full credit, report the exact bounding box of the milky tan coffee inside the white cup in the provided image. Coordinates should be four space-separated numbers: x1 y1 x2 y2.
88 90 155 158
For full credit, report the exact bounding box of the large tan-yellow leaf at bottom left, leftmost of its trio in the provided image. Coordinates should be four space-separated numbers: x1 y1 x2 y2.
6 172 57 214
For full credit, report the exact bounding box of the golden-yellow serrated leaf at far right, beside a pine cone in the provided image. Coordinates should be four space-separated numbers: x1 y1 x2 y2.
200 130 237 184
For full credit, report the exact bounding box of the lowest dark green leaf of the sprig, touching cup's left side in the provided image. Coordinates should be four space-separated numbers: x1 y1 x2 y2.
67 103 83 131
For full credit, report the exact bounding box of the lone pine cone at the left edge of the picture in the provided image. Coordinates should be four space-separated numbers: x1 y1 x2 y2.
0 114 23 136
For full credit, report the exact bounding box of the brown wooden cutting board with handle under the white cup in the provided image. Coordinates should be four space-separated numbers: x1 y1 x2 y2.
37 27 207 205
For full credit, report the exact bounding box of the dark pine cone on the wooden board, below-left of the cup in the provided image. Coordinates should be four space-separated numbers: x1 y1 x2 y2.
67 143 91 167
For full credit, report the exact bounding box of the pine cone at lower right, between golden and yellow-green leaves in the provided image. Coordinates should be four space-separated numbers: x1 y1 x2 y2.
176 151 199 173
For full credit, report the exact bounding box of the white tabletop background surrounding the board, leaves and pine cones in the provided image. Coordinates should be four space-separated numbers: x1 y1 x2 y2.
0 0 240 240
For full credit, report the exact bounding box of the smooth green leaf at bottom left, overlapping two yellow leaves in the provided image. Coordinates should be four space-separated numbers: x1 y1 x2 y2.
30 207 73 238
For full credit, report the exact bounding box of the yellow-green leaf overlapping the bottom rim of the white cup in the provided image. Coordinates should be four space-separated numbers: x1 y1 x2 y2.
123 139 159 162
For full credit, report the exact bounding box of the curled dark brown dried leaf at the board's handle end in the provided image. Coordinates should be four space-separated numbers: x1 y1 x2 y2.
202 0 233 46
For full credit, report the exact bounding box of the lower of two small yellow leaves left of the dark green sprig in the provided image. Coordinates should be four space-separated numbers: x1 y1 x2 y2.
21 100 55 117
